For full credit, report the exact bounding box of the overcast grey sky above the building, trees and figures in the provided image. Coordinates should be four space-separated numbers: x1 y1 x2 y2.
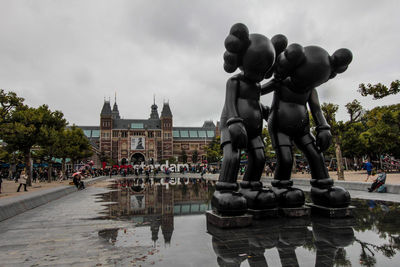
0 0 400 126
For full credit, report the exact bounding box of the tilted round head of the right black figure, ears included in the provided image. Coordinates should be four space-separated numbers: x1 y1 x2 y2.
275 44 353 90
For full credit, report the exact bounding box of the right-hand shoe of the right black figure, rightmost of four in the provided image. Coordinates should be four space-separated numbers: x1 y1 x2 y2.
311 186 351 208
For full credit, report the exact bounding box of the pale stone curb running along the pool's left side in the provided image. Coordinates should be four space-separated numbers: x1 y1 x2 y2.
0 176 108 222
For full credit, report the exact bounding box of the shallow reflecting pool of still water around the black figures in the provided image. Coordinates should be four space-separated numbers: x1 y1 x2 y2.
93 179 400 266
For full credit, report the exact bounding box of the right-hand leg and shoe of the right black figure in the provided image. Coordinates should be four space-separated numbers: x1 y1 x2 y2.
295 134 350 208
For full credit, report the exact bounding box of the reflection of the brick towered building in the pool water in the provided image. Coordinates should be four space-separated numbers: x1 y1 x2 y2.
99 179 215 248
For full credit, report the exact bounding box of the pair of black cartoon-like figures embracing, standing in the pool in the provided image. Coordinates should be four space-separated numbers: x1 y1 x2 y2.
212 23 352 215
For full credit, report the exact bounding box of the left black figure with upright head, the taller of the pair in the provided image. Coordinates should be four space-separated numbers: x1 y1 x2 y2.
212 23 287 215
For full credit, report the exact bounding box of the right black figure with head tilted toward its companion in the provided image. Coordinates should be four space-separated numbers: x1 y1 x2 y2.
262 44 352 208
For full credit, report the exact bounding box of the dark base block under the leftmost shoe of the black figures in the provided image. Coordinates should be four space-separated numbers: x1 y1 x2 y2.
206 210 253 228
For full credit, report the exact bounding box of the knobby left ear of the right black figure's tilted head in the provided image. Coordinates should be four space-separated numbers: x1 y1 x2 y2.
275 43 305 79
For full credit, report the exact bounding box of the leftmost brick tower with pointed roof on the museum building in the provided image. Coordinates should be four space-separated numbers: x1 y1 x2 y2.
100 100 112 157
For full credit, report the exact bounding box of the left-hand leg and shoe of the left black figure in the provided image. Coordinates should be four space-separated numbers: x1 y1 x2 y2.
211 143 247 215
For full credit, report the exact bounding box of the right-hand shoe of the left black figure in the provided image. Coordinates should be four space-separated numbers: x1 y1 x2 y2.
239 181 278 210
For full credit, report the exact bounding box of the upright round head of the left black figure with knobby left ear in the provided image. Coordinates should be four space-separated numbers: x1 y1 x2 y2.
224 23 275 82
